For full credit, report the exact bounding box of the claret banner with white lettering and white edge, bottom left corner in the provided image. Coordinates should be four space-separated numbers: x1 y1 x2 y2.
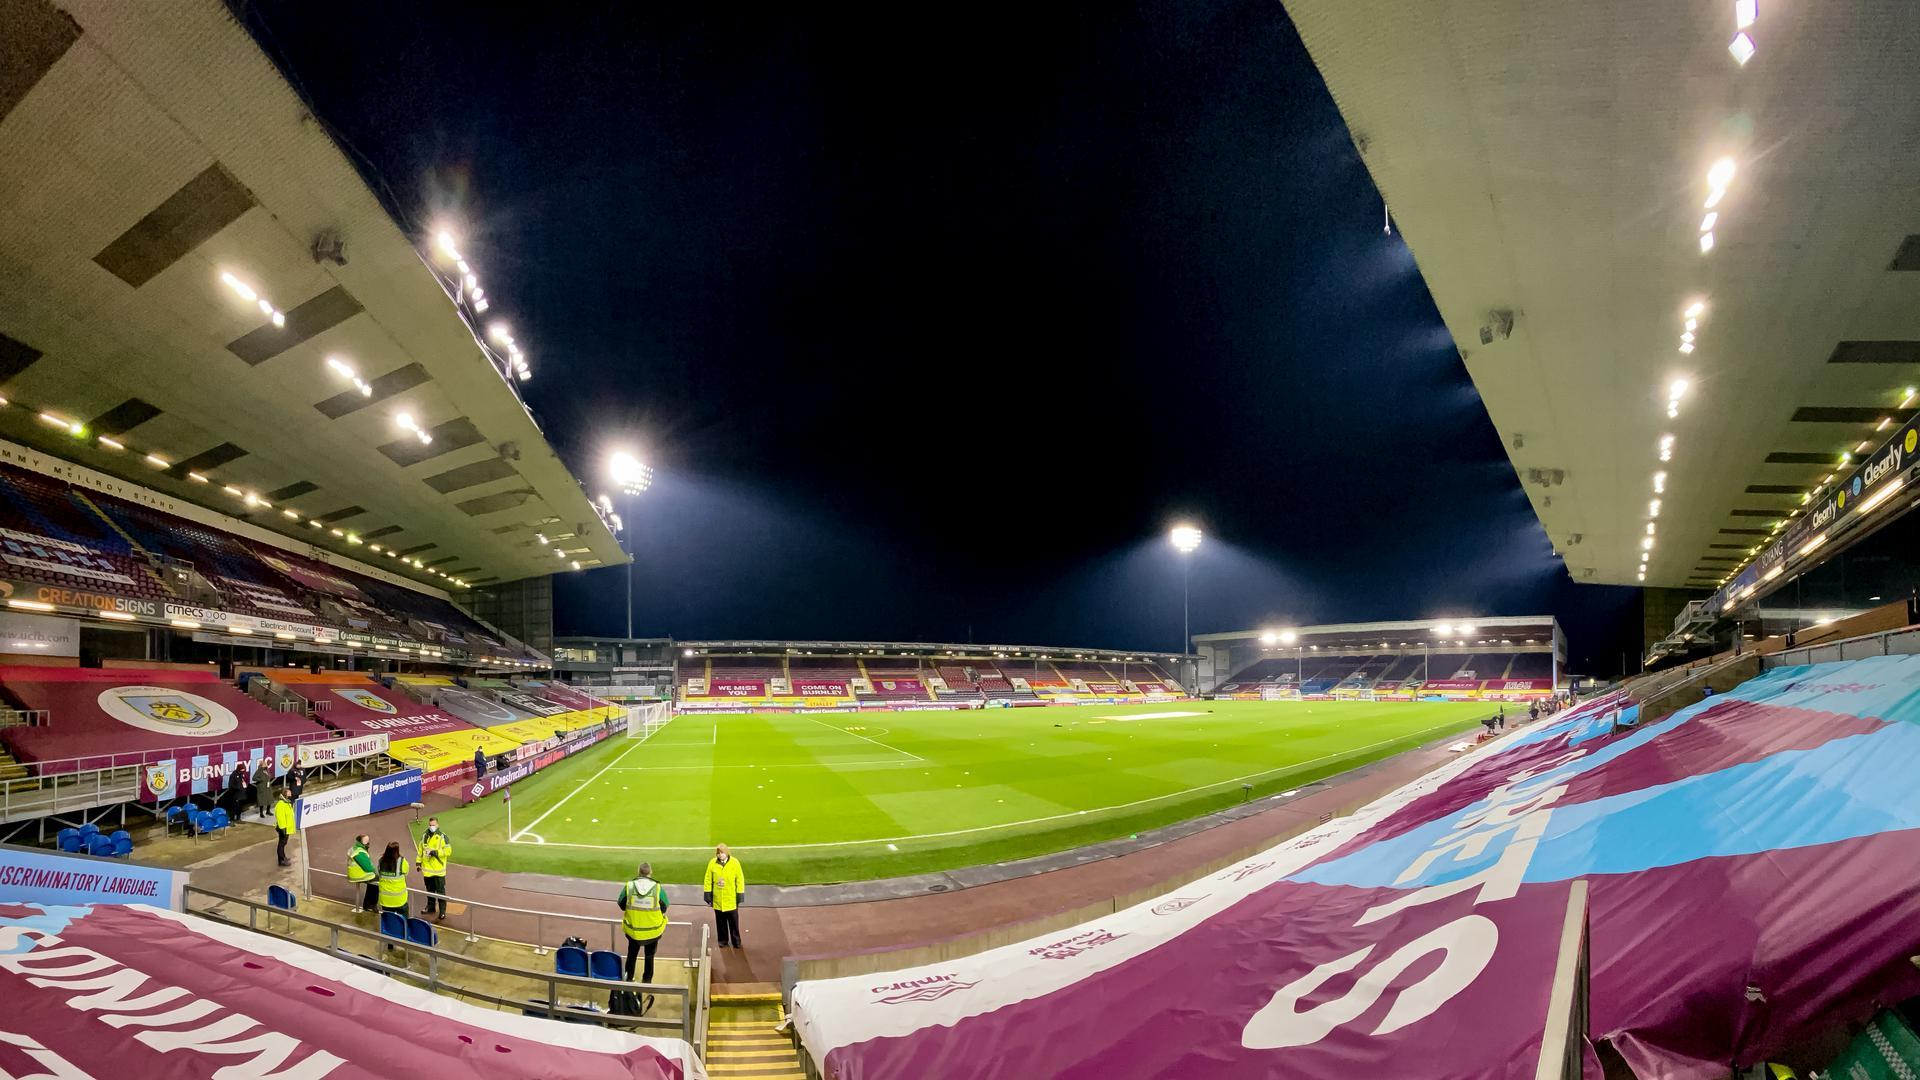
0 903 707 1080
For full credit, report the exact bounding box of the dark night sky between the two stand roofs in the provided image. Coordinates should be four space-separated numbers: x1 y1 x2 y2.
232 0 1638 671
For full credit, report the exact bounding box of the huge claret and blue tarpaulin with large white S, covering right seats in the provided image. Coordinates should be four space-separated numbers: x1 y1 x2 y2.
795 657 1920 1080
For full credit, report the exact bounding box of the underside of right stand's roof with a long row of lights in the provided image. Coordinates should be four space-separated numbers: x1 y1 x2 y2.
1286 0 1920 586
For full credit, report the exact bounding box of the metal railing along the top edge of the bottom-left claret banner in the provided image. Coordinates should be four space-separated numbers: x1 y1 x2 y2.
180 884 705 1045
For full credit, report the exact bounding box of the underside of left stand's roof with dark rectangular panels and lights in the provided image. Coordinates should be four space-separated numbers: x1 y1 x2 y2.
0 0 626 586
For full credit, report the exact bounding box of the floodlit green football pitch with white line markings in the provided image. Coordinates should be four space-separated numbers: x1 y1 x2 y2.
428 701 1489 884
